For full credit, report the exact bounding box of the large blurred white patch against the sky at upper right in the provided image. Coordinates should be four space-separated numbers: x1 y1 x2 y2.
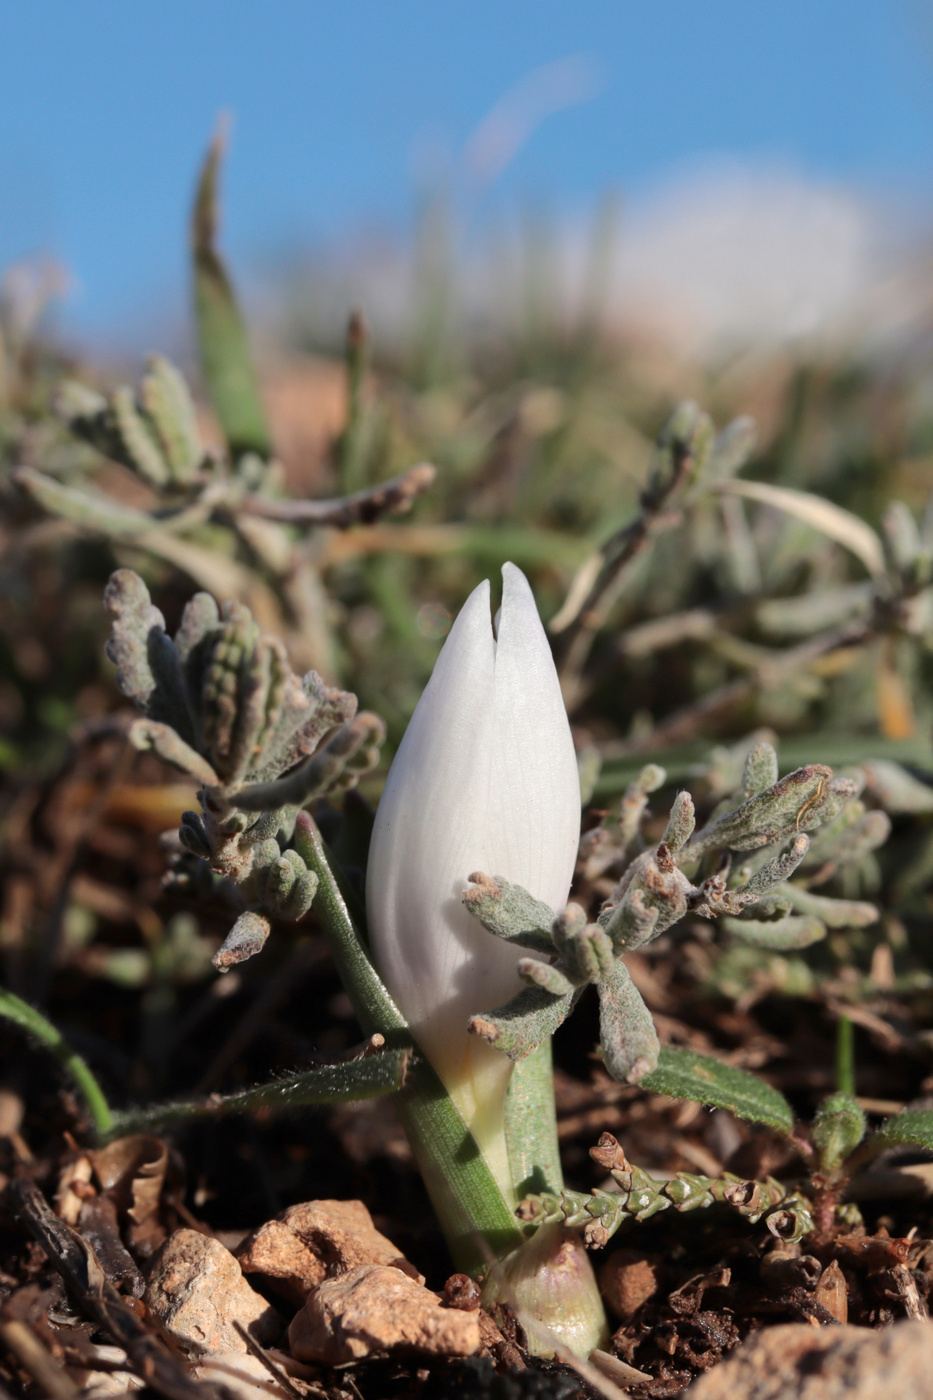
614 162 890 353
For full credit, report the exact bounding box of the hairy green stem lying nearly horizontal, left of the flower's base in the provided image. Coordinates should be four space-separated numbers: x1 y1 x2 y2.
108 1050 410 1137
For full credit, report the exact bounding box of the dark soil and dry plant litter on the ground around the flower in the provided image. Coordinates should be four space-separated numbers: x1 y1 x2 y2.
0 722 933 1400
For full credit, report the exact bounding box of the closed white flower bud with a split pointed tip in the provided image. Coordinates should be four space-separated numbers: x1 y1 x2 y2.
366 564 580 1175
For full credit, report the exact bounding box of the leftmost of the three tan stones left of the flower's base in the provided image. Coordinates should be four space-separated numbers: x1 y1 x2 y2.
146 1229 282 1352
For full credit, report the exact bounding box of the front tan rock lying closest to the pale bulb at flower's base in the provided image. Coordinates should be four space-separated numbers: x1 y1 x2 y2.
289 1264 481 1366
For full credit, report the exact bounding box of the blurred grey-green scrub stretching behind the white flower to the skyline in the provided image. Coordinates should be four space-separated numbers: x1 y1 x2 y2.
0 143 933 1125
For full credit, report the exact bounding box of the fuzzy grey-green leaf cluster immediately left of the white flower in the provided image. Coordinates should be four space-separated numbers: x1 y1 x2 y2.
105 568 384 970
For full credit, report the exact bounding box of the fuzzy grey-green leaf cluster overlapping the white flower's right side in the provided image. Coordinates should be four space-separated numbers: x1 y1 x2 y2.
464 742 890 1084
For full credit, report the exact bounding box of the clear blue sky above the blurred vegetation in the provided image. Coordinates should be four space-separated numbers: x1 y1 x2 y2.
0 0 933 342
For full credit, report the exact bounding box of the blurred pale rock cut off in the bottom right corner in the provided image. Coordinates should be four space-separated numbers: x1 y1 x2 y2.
685 1320 933 1400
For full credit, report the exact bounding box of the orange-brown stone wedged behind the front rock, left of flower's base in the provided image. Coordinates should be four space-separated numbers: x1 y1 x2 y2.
235 1201 424 1308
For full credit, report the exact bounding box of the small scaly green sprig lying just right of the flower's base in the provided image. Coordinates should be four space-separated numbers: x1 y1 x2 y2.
518 1133 813 1249
